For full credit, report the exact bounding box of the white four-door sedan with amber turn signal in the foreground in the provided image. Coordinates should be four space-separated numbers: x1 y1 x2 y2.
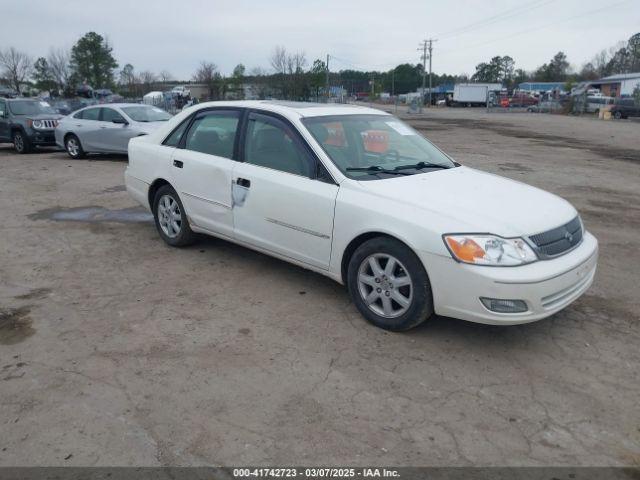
125 101 598 330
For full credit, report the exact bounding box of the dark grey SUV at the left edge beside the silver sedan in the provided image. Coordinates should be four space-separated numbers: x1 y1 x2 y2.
0 98 62 153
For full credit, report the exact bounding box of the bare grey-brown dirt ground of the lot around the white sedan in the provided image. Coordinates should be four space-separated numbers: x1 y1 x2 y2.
0 109 640 466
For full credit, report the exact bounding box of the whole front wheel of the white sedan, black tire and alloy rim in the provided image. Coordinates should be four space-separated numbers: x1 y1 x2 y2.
347 237 433 332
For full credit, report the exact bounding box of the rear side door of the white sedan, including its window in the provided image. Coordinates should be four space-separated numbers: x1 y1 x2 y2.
172 110 240 237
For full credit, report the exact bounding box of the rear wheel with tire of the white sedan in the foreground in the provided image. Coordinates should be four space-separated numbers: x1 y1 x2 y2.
153 185 196 247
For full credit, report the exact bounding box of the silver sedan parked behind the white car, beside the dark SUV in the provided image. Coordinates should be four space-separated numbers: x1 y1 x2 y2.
55 103 171 158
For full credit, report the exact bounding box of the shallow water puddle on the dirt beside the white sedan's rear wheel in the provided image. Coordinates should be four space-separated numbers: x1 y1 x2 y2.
28 206 153 223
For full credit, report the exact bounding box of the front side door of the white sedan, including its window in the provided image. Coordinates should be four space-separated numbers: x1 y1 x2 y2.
233 112 338 269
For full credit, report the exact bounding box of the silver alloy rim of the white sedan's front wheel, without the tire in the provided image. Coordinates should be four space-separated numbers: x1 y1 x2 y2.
358 253 413 318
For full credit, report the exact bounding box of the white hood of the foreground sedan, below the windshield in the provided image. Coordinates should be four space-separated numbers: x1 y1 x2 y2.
359 167 577 237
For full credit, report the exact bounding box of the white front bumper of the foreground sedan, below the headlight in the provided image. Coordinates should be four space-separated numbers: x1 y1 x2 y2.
420 232 598 325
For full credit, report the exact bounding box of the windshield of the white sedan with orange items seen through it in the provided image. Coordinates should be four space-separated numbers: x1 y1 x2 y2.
302 115 456 180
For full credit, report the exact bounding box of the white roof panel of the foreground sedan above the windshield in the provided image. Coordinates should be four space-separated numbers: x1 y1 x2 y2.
189 100 389 118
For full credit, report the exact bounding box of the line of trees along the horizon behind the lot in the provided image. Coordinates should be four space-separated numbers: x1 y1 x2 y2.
0 32 640 100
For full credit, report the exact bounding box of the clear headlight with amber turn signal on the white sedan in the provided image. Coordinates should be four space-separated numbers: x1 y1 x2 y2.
444 234 538 267
